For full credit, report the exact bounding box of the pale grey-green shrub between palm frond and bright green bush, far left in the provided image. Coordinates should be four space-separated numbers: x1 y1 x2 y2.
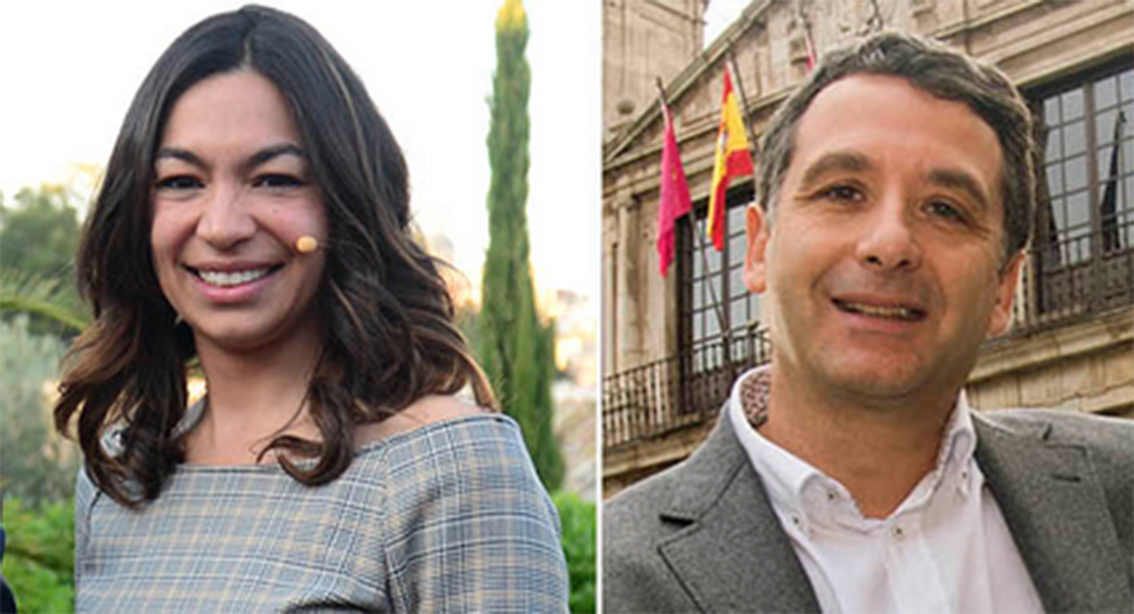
0 314 78 506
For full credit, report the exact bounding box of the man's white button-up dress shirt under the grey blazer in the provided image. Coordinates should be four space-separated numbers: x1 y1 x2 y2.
727 367 1043 614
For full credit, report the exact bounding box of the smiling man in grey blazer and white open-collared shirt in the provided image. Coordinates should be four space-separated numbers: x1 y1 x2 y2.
603 29 1134 614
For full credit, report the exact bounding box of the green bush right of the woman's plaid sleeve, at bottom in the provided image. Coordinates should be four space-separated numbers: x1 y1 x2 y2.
552 493 595 614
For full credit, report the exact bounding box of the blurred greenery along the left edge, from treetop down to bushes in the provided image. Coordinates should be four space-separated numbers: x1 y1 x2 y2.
0 185 82 614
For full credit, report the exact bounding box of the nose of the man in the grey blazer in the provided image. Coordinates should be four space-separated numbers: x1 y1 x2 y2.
855 194 922 271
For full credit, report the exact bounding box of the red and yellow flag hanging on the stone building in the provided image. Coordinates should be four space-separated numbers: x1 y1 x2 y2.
708 67 753 252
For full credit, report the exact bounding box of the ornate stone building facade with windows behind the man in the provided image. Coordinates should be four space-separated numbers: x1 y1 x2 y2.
602 0 1134 495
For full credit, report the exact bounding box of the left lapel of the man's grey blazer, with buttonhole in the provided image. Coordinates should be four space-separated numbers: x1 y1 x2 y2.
658 412 820 614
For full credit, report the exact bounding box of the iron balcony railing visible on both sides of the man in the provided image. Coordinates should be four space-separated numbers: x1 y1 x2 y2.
602 222 1134 449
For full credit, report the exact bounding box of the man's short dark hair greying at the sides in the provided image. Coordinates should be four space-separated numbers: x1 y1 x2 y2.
758 32 1035 262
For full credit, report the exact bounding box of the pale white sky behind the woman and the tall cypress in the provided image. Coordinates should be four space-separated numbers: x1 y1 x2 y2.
0 0 602 302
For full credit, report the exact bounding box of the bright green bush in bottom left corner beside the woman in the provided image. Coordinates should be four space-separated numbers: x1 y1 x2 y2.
3 497 75 614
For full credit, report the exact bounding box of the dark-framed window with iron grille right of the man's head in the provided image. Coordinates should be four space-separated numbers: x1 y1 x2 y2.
1031 61 1134 316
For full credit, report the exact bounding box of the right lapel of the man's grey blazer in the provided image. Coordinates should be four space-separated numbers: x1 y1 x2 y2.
973 413 1134 614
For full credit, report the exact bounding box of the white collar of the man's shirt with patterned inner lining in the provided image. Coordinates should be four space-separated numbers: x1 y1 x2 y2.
726 364 976 529
